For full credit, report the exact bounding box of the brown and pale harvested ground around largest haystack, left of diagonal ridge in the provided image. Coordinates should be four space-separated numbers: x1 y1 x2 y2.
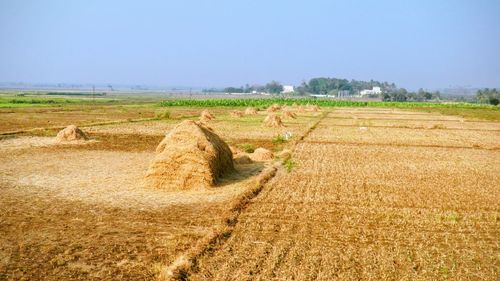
0 143 270 279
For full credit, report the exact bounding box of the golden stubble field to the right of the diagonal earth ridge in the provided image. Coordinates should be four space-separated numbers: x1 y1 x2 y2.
188 109 500 280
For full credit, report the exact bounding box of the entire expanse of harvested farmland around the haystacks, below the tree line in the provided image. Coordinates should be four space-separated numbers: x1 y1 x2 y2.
0 99 500 280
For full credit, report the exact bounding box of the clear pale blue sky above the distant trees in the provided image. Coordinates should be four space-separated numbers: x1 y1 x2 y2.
0 0 500 89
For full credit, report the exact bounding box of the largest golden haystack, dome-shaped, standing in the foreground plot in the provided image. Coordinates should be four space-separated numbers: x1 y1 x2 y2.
146 120 234 191
